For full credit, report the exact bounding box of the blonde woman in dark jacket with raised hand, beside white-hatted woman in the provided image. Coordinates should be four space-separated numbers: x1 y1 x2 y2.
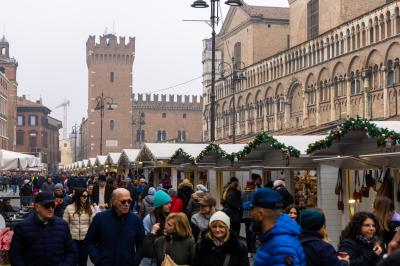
143 213 195 265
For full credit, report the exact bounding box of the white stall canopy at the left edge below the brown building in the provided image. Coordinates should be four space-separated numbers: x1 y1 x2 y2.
0 150 40 170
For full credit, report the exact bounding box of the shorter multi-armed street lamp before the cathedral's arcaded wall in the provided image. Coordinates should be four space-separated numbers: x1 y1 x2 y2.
219 57 246 144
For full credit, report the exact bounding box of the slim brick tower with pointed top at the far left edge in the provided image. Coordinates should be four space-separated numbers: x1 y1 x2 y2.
0 35 18 150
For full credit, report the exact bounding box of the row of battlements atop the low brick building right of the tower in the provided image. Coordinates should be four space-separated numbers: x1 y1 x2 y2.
133 93 203 106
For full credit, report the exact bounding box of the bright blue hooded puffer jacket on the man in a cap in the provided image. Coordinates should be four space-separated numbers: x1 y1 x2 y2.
254 214 306 266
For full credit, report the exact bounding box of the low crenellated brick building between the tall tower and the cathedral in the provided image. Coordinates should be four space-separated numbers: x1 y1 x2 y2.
132 94 203 148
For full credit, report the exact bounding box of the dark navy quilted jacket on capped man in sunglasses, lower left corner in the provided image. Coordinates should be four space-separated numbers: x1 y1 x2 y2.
10 213 76 266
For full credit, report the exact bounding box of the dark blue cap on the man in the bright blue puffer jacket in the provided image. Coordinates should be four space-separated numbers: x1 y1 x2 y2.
247 188 283 210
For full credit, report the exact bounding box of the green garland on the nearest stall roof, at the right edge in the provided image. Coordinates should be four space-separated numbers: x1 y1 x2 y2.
307 117 400 154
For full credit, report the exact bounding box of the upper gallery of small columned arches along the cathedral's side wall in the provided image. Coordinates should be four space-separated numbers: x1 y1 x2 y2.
216 5 400 103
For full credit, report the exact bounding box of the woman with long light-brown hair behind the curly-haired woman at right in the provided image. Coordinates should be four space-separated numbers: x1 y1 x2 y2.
373 196 400 249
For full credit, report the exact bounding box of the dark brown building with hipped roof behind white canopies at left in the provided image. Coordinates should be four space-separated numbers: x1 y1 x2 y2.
16 95 62 173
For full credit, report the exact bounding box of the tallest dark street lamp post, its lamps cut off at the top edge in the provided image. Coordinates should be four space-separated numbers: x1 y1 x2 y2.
191 0 243 142
